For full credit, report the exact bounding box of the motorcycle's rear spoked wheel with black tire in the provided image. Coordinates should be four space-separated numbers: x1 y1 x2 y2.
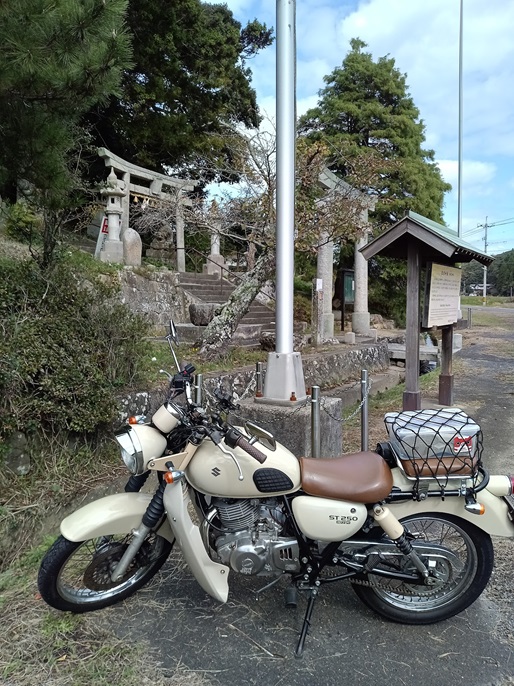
352 513 494 624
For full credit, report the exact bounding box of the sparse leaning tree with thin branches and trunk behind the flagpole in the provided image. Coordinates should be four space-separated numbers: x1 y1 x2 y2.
130 132 383 358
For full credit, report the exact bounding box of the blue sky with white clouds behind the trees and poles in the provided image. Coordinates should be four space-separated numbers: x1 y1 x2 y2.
210 0 514 255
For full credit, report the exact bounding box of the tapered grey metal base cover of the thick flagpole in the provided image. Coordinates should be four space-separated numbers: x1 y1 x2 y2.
258 352 307 406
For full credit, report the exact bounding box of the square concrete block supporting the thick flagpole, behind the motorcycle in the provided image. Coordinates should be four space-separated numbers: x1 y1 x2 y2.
234 397 343 457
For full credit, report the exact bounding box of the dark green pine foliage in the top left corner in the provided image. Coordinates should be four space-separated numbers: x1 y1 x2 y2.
0 0 130 204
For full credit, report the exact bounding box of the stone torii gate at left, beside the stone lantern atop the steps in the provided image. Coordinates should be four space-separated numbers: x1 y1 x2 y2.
98 148 198 272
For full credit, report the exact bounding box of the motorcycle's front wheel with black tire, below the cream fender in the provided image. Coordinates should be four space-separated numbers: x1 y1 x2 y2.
38 533 172 613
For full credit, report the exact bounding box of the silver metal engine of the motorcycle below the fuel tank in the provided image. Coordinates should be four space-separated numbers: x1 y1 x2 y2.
210 498 300 576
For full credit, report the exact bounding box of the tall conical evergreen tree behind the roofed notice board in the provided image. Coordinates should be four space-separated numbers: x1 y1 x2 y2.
299 39 451 223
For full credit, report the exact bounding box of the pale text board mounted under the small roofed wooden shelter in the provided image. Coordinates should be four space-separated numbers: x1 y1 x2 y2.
423 262 462 328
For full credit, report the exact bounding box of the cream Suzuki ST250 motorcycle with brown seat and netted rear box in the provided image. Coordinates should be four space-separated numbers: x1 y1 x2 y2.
38 322 514 657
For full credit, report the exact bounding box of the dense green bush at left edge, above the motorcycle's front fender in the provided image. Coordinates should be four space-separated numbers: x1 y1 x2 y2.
0 259 147 436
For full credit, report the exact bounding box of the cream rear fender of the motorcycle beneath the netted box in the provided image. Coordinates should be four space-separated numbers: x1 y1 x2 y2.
387 489 514 538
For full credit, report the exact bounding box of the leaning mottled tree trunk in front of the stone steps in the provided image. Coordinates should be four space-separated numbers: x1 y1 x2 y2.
200 251 275 360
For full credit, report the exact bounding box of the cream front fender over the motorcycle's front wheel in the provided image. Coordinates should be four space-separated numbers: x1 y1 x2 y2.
61 493 175 543
